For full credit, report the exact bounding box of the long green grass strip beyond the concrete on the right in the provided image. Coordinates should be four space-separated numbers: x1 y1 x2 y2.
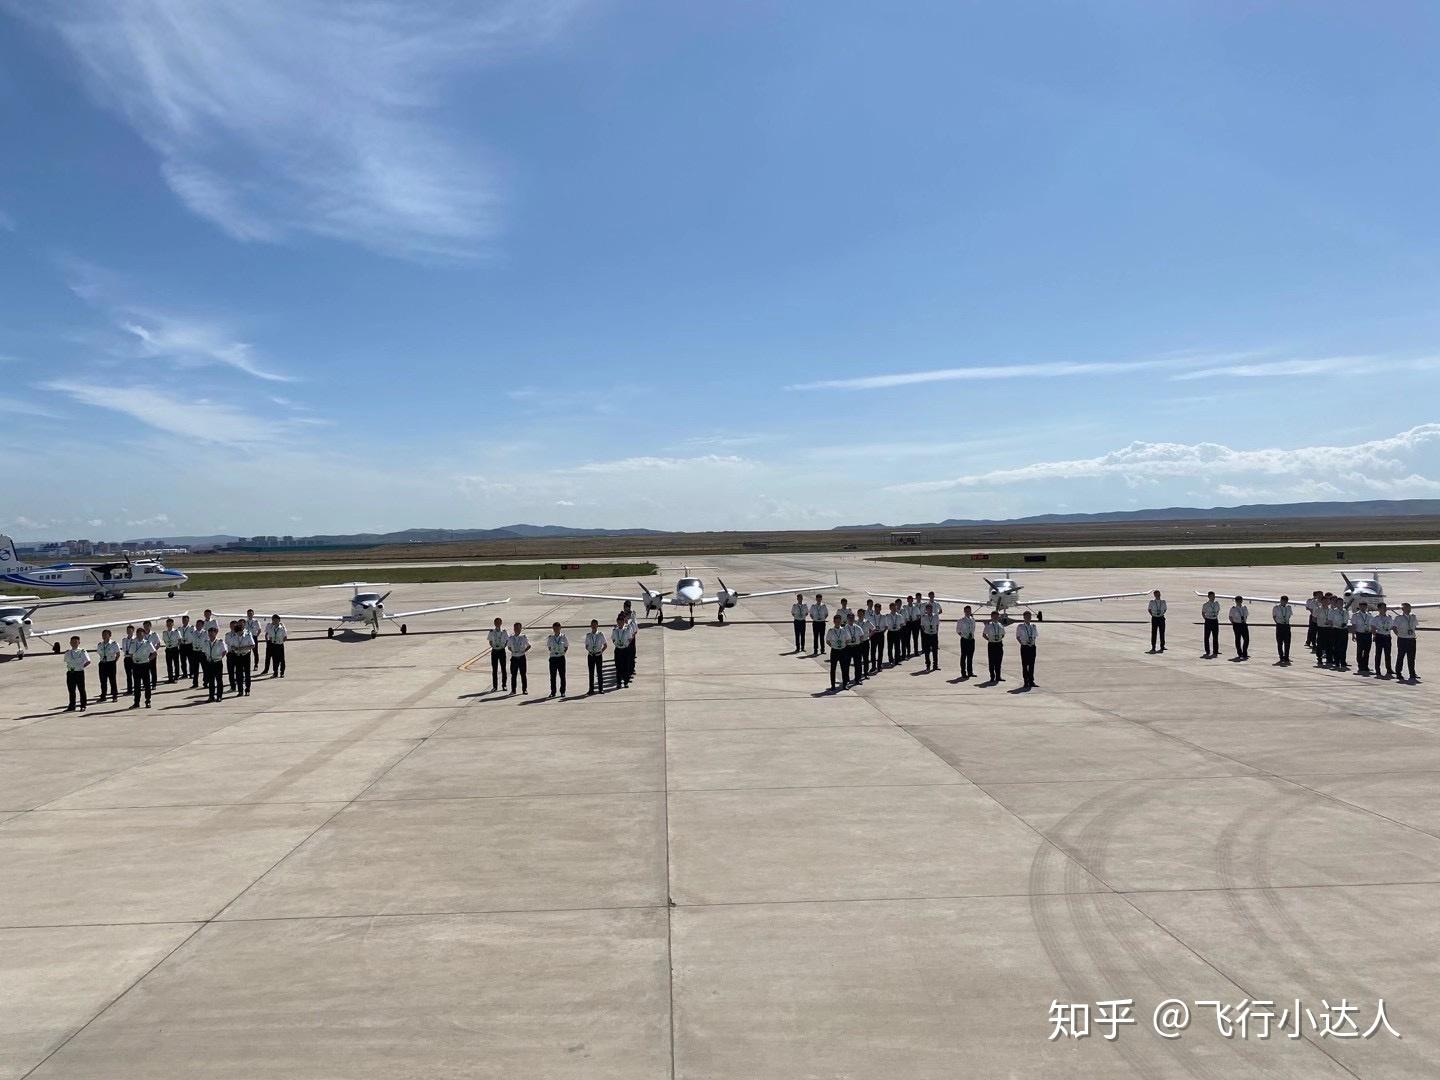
874 544 1440 573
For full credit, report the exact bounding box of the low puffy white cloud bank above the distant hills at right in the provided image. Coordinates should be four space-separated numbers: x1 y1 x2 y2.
887 423 1440 495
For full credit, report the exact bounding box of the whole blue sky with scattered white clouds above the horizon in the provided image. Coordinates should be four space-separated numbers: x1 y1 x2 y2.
0 0 1440 539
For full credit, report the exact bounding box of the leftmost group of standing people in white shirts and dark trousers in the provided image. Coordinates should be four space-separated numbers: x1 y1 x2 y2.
65 608 289 713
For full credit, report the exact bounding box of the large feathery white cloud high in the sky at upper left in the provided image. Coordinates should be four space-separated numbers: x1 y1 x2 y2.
16 0 579 256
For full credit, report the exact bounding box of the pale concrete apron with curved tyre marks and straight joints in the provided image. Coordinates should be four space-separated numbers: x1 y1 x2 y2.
0 554 1440 1080
